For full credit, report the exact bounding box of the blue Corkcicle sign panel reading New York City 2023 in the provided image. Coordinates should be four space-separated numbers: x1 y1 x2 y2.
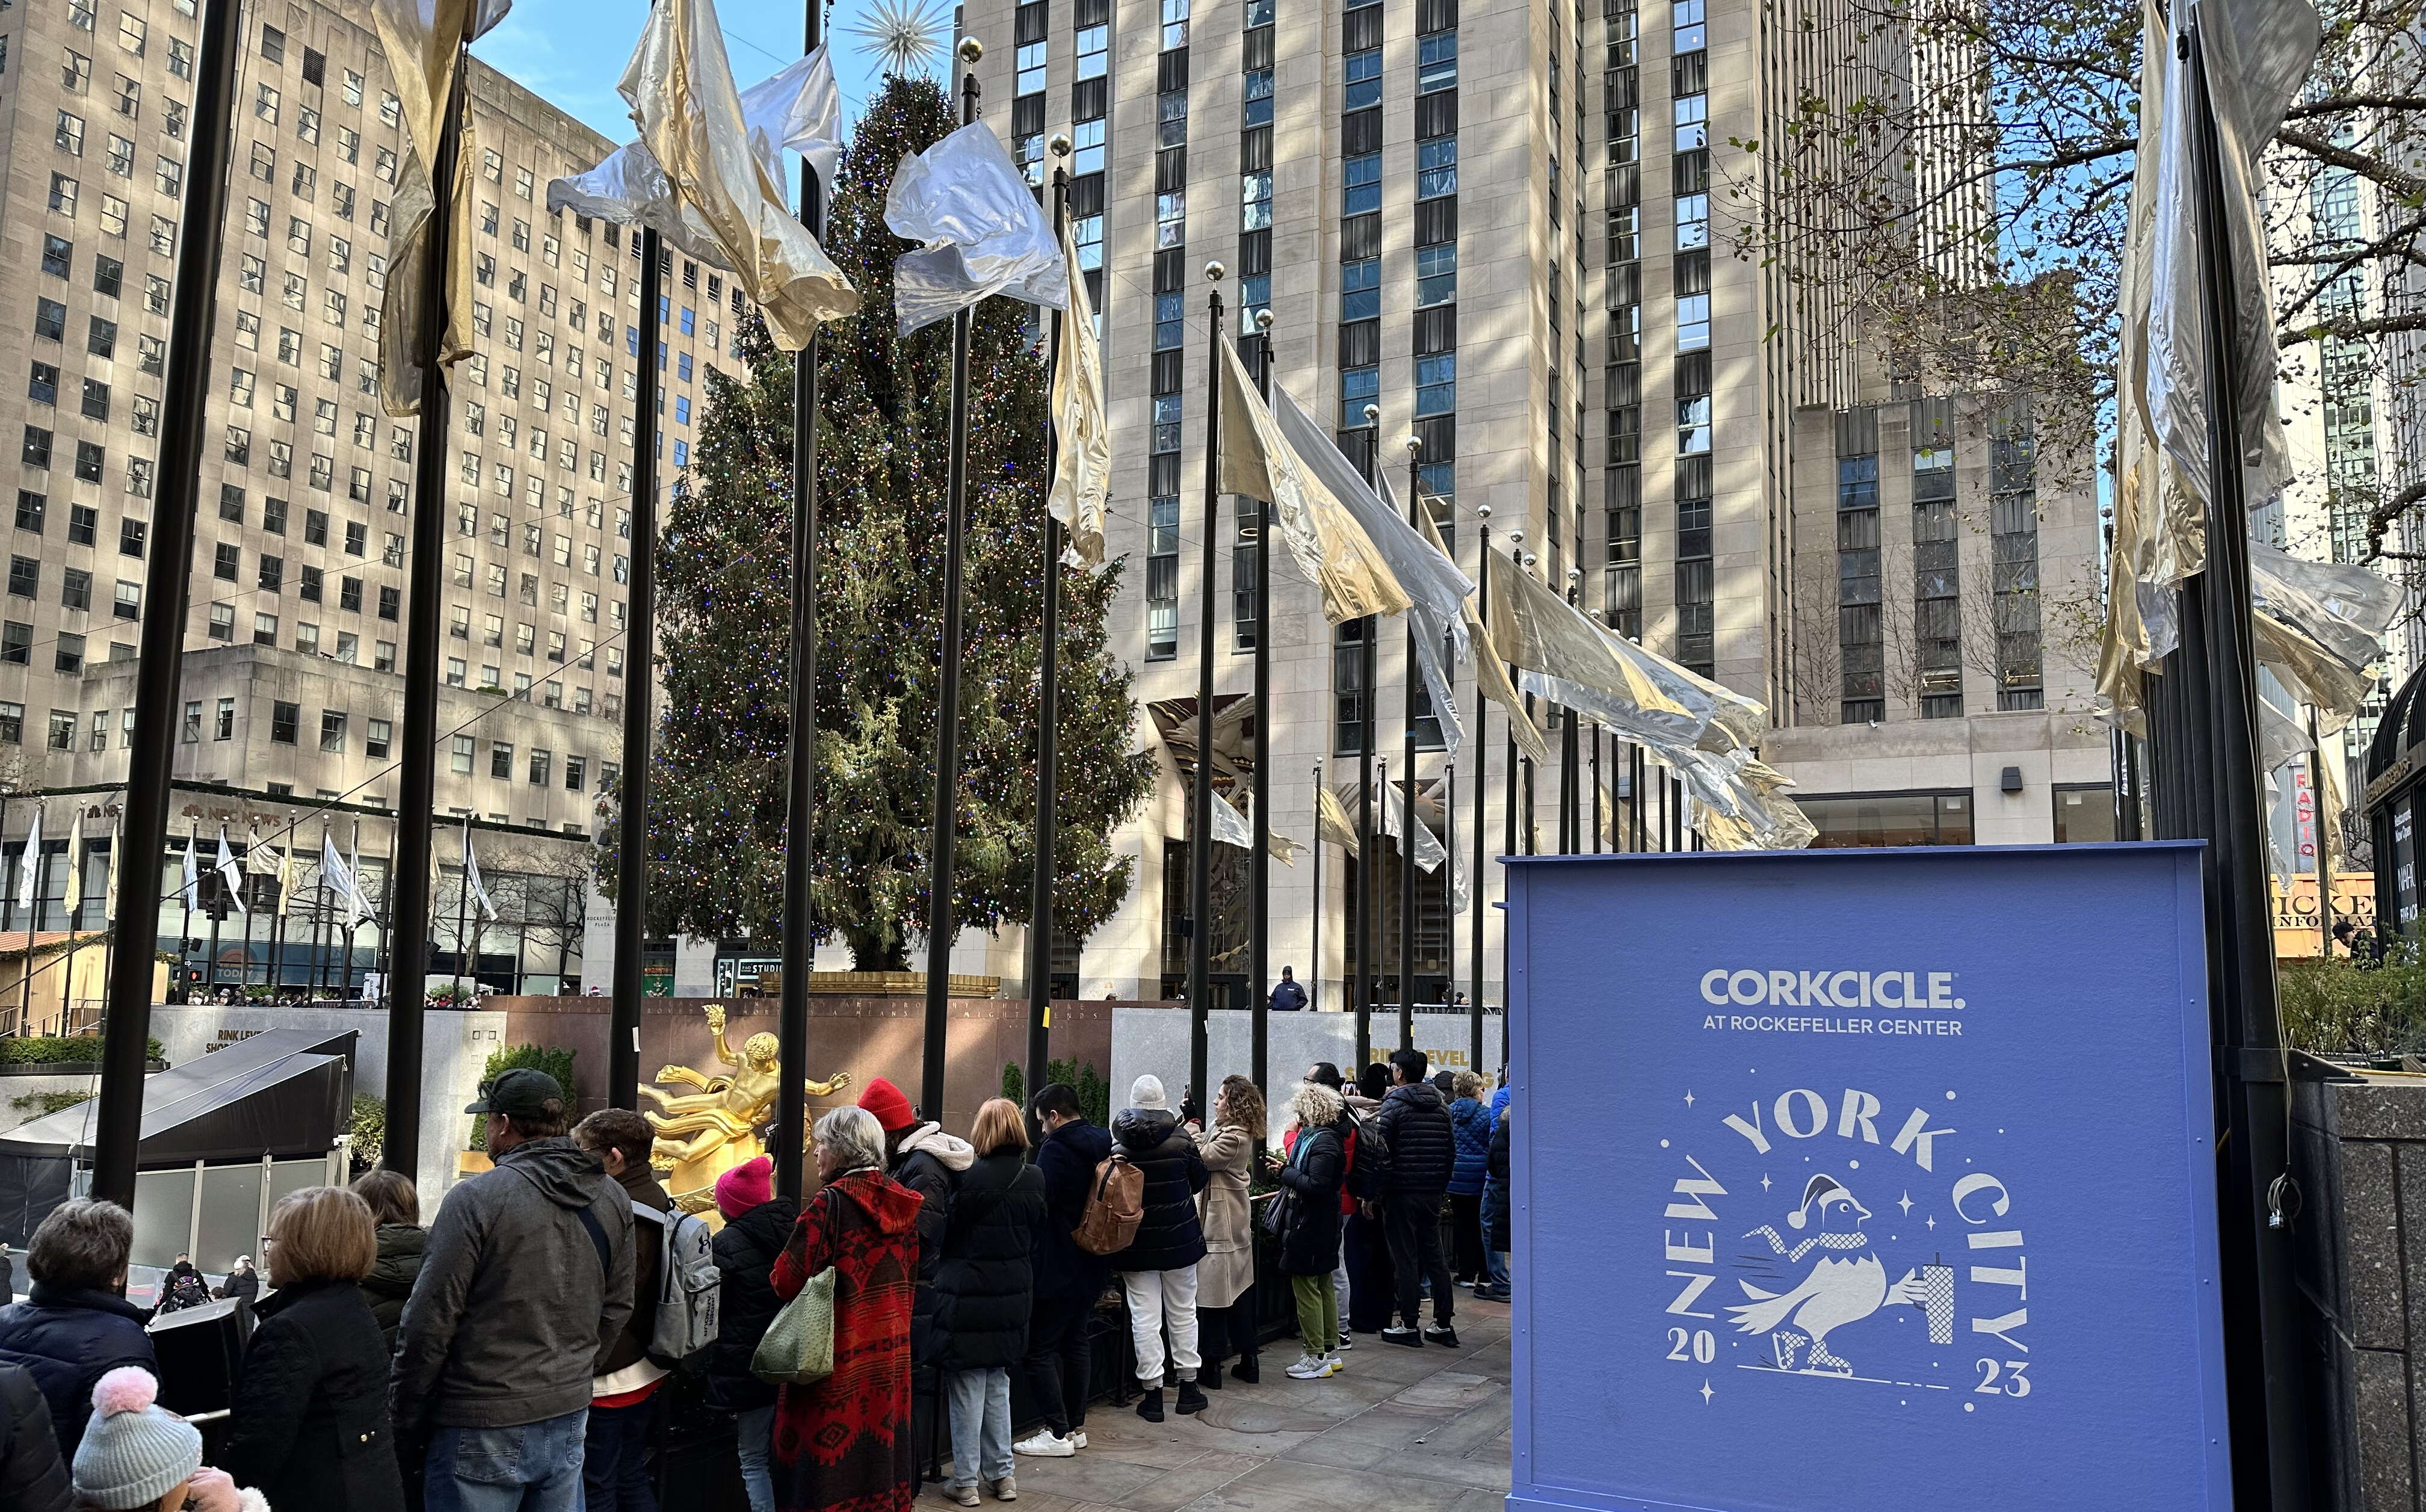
1509 845 2232 1512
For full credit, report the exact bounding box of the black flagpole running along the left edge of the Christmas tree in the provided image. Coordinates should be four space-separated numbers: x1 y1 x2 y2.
606 230 669 1106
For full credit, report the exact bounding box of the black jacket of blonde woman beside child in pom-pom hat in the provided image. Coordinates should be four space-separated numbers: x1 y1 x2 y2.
214 1282 405 1512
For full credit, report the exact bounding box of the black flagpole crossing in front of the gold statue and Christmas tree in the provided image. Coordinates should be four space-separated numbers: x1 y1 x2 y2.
771 0 844 1202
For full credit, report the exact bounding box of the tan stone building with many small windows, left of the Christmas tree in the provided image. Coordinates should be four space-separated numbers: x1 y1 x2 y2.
0 0 718 990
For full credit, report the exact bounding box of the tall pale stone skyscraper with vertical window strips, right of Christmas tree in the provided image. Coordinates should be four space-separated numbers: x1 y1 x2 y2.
961 0 2108 1005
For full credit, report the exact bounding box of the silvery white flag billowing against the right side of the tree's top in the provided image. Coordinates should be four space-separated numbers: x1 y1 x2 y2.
886 122 1070 335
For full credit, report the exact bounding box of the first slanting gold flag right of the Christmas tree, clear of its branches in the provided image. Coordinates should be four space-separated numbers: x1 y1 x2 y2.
1213 338 1410 624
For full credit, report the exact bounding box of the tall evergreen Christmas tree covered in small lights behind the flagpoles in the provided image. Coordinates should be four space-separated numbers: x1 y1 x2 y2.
599 75 1152 970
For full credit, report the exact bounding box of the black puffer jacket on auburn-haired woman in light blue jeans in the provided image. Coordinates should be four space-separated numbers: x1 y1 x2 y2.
934 1146 1046 1371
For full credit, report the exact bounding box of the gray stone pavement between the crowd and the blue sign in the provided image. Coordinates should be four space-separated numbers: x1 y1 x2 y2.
970 1294 1509 1512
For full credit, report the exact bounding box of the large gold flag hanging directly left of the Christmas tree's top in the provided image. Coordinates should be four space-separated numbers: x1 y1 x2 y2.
616 0 859 352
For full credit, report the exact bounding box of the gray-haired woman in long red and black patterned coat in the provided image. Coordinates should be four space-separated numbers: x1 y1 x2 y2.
771 1106 919 1512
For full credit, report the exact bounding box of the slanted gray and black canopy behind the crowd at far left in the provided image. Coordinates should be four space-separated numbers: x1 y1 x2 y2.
0 1029 357 1245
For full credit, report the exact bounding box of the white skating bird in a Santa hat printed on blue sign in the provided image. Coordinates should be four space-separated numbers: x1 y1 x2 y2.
1727 1174 1924 1376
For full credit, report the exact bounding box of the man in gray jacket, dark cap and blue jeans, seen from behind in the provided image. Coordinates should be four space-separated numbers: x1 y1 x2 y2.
388 1068 633 1512
